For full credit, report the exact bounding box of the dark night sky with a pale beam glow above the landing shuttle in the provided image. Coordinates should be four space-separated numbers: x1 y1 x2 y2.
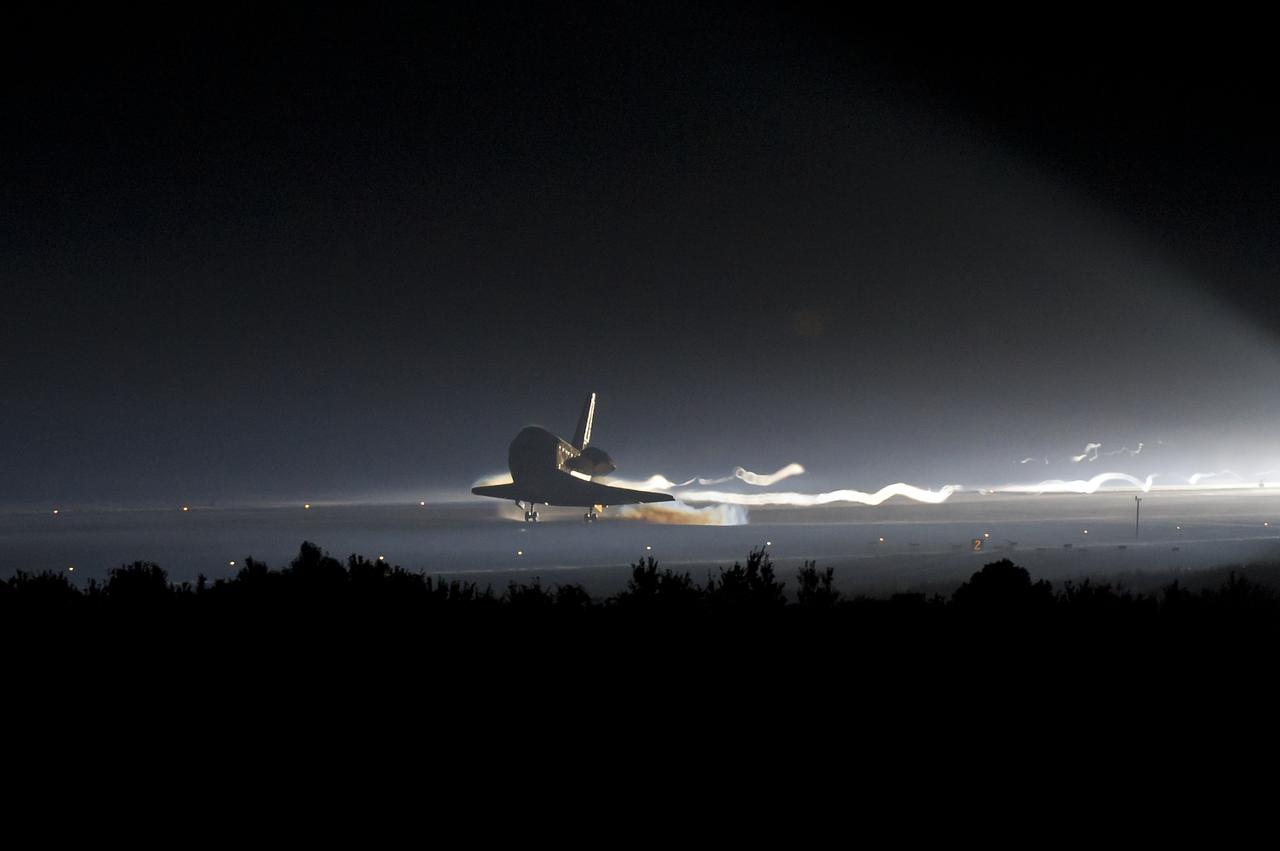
0 3 1280 507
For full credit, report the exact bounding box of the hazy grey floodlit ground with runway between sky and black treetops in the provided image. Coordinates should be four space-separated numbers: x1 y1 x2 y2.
0 490 1280 595
